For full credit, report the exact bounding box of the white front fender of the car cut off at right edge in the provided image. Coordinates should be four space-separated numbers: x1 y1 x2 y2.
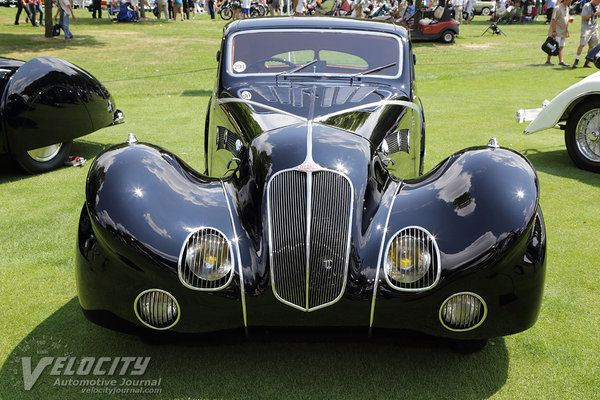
523 72 600 134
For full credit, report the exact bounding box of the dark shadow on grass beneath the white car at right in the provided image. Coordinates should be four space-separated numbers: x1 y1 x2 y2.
522 149 600 187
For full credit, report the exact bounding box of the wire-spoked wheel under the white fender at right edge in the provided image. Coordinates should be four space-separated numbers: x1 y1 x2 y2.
565 99 600 172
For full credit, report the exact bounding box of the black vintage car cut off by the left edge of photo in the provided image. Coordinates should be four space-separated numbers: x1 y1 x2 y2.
0 57 122 173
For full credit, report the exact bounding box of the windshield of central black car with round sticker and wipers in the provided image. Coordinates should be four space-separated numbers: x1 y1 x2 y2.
227 30 402 78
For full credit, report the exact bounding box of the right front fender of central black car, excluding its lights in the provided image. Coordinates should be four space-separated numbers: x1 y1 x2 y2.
373 147 546 339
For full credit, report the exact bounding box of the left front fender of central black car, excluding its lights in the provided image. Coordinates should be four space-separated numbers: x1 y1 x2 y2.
76 142 243 332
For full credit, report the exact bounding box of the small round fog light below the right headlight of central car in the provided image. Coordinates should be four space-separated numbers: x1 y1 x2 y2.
440 292 487 332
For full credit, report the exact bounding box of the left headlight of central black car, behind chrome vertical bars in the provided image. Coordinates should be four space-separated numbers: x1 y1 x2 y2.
179 228 233 290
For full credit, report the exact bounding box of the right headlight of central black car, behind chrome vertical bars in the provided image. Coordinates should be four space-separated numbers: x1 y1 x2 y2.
384 227 440 290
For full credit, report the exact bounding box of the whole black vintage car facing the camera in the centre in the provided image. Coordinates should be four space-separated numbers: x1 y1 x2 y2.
76 17 546 351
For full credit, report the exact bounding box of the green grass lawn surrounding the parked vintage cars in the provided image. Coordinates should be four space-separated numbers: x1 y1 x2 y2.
0 7 600 400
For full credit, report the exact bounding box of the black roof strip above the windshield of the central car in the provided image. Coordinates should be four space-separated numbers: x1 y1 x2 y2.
223 16 408 39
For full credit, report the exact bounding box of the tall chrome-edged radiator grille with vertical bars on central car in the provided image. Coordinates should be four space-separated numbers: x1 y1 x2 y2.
268 170 353 311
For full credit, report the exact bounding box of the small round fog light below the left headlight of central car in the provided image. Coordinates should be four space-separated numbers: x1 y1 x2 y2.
133 289 180 330
